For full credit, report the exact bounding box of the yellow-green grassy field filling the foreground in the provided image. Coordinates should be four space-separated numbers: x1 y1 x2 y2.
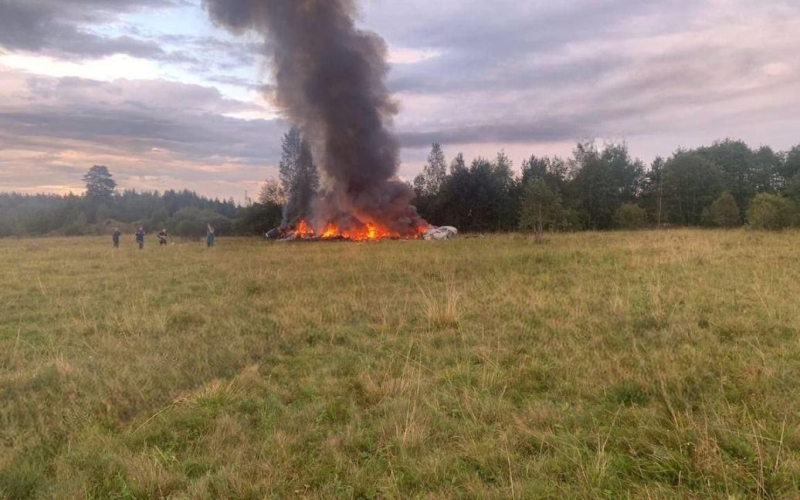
0 230 800 499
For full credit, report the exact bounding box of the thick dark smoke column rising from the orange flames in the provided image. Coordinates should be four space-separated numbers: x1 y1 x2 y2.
205 0 427 234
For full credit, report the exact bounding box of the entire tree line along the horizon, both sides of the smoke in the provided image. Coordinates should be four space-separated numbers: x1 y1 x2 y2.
0 133 800 237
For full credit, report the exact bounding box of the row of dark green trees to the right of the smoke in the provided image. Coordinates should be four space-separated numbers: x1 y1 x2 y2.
413 139 800 235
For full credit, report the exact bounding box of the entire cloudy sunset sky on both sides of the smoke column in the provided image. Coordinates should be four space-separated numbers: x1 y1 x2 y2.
0 0 800 202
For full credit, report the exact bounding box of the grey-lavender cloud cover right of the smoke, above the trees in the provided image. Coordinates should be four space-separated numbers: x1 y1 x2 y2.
374 0 800 151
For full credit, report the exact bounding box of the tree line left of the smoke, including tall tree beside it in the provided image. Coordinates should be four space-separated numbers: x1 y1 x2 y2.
0 128 320 238
